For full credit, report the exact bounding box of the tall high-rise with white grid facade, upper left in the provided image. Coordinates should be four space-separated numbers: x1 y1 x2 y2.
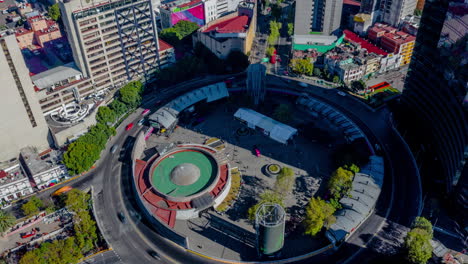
59 0 160 90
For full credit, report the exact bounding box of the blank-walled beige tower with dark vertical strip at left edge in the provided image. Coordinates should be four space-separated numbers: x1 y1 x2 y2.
0 35 49 161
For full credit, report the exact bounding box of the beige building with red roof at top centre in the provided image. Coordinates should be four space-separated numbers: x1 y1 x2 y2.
193 2 257 59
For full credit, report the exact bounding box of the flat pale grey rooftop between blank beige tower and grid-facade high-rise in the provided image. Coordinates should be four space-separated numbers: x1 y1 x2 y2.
31 62 81 89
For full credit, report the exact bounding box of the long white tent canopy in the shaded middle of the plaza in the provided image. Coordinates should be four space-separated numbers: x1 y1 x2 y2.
234 108 297 144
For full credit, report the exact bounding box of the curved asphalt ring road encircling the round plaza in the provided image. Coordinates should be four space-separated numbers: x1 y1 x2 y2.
37 76 419 263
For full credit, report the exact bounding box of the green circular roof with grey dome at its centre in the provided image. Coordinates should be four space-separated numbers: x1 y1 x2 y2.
154 149 218 197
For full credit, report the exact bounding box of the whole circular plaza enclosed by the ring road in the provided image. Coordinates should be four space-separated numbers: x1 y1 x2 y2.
131 83 383 263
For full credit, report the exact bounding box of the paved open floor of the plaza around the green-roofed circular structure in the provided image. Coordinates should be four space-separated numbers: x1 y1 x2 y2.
146 95 344 260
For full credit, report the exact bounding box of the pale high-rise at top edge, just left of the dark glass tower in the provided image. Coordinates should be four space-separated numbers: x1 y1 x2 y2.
379 0 417 26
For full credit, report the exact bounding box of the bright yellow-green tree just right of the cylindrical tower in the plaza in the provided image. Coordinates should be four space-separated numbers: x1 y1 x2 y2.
304 197 336 236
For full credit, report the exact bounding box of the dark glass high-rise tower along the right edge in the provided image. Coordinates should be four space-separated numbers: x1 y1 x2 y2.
398 0 468 200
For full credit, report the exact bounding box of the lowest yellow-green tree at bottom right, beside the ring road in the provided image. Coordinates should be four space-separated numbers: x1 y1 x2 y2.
405 228 432 264
